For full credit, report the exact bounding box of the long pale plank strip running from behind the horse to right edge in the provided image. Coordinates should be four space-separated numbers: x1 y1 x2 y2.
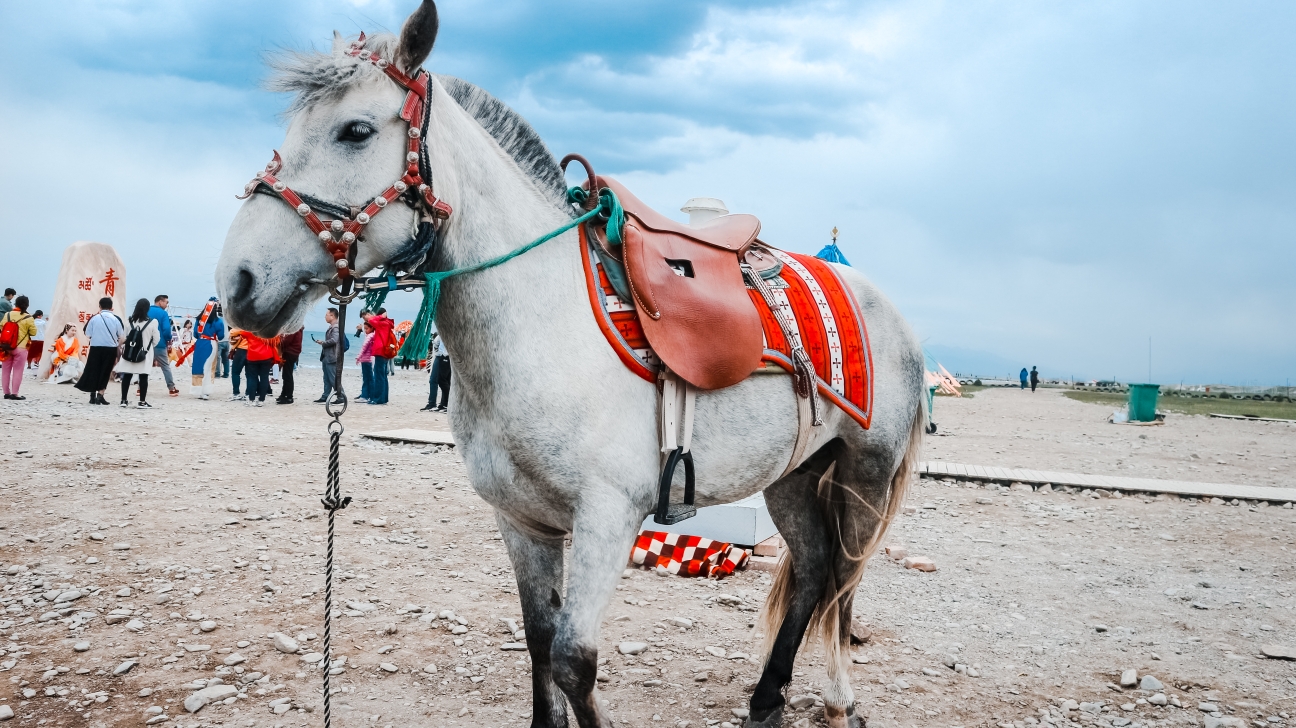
919 461 1296 503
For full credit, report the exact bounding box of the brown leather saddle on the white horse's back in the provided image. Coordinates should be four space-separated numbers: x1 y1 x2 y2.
584 175 770 390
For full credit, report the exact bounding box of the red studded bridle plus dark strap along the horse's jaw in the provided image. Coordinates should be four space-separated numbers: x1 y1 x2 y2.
238 34 451 279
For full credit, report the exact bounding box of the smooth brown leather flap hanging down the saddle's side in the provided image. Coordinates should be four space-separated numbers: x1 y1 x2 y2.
618 221 765 390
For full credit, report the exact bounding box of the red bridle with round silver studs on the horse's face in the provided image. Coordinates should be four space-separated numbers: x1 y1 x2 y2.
238 32 451 279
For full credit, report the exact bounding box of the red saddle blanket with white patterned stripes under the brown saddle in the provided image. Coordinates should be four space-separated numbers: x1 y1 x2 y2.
579 226 874 429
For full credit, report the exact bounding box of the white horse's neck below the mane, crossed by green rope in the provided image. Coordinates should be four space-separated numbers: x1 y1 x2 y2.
428 79 590 393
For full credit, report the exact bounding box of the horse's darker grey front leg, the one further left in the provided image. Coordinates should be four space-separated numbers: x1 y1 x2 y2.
495 512 568 728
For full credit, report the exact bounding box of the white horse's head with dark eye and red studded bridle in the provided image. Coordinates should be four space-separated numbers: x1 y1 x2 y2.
216 0 438 336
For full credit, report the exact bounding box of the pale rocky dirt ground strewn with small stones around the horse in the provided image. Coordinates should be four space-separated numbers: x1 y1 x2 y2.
0 372 1296 728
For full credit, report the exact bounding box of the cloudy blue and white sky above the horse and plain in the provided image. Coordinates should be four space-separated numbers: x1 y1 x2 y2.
0 0 1296 383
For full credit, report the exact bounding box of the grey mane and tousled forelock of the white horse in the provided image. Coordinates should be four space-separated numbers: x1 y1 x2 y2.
266 32 572 214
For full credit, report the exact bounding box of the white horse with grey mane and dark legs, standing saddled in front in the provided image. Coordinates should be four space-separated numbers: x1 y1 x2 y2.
216 0 924 728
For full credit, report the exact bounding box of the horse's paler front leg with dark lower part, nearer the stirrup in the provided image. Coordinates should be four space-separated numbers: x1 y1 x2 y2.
553 492 643 728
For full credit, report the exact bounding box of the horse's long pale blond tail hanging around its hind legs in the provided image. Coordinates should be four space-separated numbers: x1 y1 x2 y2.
761 402 927 676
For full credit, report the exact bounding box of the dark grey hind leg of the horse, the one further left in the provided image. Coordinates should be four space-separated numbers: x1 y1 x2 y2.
745 446 837 728
